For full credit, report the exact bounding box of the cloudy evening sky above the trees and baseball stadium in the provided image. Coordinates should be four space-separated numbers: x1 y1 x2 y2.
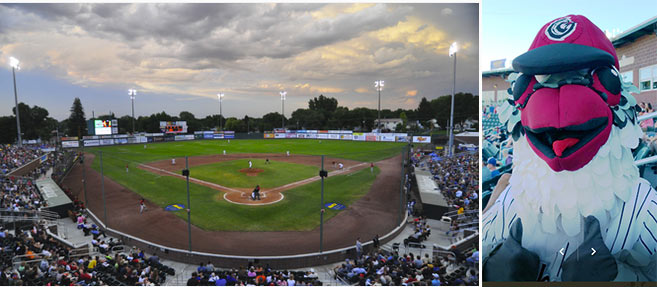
0 3 479 120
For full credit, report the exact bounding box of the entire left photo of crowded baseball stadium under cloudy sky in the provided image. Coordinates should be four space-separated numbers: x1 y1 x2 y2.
0 3 480 286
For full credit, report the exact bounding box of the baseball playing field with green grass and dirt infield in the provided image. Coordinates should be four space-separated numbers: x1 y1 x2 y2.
85 139 405 231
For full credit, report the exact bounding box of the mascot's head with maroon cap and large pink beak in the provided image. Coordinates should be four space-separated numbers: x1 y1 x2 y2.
512 15 621 171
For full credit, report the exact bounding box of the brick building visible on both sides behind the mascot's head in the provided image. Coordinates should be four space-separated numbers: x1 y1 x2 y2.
481 16 657 107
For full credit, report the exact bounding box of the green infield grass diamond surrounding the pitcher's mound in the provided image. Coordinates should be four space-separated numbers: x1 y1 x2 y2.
190 158 319 188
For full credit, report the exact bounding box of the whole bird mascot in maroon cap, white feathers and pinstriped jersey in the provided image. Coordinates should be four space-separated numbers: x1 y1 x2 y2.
481 15 657 281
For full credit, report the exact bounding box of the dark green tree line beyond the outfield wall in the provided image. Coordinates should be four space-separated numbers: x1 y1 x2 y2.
0 93 479 143
